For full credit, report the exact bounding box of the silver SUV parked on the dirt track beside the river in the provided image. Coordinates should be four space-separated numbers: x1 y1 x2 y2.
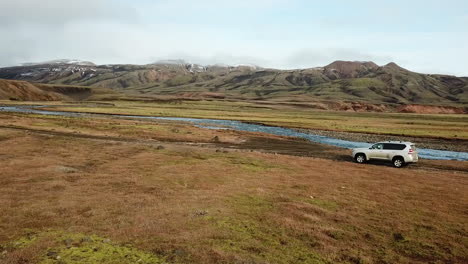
352 141 418 168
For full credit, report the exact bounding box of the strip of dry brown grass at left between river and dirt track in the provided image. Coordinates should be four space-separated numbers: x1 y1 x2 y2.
0 113 252 143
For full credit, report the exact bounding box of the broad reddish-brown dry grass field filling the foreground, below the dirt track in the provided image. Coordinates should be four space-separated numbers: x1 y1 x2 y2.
0 116 468 263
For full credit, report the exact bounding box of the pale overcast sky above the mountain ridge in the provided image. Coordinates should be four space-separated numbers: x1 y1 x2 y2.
0 0 468 76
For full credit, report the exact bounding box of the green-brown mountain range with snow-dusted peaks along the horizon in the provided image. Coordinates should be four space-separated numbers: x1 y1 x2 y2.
0 60 468 107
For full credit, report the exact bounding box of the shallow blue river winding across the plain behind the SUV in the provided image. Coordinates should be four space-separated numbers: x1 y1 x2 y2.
0 106 468 161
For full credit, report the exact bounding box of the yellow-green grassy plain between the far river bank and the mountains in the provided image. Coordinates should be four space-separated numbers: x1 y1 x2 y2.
18 101 468 139
